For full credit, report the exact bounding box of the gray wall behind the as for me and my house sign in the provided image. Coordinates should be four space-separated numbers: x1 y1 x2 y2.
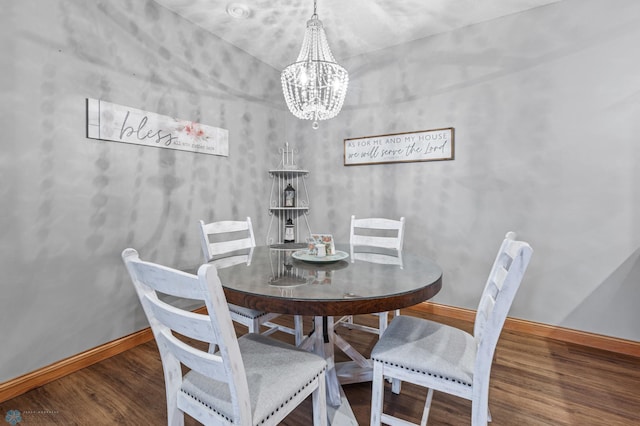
296 0 640 340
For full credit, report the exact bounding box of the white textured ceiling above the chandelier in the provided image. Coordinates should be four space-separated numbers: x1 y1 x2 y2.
150 0 559 69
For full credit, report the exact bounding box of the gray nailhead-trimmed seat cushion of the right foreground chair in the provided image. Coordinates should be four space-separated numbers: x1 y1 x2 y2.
371 315 476 386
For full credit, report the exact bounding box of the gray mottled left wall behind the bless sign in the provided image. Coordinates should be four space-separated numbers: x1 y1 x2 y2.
0 0 284 382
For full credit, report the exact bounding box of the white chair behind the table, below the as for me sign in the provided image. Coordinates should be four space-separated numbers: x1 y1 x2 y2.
336 215 405 336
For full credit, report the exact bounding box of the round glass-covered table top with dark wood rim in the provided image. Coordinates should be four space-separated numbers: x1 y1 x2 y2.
211 244 442 316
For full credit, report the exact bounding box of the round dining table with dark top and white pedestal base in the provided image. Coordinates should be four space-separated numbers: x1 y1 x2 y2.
210 244 442 425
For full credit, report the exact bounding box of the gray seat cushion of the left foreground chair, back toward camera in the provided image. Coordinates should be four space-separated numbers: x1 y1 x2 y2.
181 333 327 424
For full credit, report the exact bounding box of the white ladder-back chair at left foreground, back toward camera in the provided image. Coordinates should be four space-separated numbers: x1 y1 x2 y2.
122 248 327 426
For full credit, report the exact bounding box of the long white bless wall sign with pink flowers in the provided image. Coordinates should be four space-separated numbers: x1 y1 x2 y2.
87 99 229 157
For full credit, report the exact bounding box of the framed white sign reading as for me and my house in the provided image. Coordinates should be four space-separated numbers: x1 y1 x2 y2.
344 127 454 166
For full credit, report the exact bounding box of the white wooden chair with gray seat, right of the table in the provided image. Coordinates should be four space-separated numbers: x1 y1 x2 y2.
371 232 533 426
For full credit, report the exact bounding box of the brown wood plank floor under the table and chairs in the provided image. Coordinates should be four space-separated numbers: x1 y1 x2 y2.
0 309 640 426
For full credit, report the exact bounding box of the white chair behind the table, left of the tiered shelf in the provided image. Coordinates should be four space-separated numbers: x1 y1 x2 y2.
199 217 303 345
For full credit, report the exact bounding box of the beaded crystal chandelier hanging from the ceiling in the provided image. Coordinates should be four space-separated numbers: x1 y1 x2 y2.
280 0 349 129
